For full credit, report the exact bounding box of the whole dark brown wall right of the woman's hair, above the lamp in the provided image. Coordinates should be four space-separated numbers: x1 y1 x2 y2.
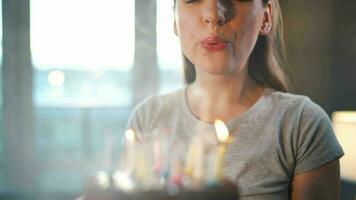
281 0 356 114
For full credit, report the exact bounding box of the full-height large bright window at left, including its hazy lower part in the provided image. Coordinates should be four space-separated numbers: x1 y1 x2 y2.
31 0 135 193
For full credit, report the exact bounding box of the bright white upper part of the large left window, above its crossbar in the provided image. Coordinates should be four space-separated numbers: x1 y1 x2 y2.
31 0 135 107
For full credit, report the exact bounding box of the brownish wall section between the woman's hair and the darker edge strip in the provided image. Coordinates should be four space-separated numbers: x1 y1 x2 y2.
280 0 332 108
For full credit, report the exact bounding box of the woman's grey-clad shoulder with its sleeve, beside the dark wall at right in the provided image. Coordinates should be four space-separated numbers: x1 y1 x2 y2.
270 91 343 174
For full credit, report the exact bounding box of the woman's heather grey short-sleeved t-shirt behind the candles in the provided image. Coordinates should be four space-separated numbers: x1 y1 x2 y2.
128 87 343 200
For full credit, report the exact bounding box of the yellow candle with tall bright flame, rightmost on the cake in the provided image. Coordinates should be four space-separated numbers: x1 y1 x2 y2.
215 120 229 180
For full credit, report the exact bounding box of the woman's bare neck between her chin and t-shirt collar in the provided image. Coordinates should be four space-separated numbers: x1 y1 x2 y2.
187 69 264 122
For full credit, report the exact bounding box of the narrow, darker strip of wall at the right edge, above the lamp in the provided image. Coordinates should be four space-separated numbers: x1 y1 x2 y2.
330 0 356 110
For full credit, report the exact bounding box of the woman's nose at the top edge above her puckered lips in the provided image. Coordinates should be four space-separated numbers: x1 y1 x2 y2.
203 0 227 26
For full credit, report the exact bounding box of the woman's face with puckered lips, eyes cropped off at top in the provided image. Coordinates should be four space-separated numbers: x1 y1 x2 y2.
174 0 271 74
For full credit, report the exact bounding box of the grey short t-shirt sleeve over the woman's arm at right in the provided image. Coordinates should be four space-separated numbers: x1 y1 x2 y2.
294 99 344 174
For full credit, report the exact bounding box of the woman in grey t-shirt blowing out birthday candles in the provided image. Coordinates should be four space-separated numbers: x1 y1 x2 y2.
129 0 343 200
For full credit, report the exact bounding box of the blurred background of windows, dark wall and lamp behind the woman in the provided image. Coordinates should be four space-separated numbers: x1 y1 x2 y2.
0 0 356 200
